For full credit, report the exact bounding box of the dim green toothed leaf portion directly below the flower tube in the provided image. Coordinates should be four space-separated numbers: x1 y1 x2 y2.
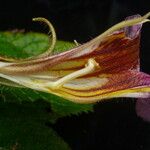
0 85 93 123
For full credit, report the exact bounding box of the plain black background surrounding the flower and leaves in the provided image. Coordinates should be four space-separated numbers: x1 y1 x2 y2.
0 0 150 150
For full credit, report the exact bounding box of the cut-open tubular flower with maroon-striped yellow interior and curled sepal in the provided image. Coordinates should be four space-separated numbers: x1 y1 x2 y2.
0 13 150 103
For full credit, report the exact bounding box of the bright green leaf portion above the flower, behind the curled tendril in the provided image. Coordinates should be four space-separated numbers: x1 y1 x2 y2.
0 32 75 58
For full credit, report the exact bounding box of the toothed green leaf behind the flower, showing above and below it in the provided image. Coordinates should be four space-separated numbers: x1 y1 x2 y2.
0 32 93 123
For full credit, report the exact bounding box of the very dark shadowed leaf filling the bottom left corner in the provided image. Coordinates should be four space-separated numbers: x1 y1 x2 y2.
0 101 70 150
